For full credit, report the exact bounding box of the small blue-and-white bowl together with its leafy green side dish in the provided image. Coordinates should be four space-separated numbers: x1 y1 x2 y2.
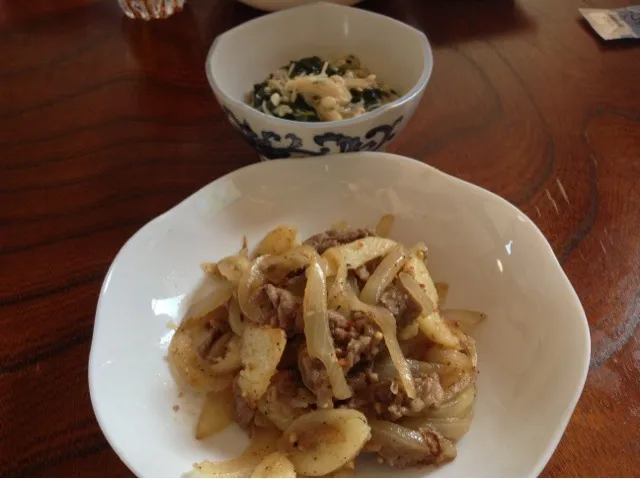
205 2 433 159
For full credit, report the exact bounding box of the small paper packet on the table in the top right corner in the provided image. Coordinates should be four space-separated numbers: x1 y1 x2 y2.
578 5 640 40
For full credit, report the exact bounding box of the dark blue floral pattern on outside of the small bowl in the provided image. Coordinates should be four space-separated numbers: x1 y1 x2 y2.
223 107 404 160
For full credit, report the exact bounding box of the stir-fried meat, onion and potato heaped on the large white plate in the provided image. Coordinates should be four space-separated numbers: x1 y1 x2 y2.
168 219 484 477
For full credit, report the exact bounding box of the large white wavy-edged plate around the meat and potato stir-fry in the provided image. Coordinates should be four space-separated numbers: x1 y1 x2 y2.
89 153 590 477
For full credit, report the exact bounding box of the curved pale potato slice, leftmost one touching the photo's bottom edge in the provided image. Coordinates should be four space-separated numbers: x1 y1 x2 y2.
186 428 281 477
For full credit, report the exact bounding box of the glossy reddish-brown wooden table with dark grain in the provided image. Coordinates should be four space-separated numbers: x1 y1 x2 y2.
0 0 640 476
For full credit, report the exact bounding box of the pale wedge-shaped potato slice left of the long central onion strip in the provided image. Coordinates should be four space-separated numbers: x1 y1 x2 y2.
238 326 287 408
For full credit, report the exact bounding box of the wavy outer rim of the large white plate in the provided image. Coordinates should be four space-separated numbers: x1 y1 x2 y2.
87 151 591 477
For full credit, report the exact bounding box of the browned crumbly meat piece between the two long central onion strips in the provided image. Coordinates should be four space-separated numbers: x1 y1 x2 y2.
328 311 384 373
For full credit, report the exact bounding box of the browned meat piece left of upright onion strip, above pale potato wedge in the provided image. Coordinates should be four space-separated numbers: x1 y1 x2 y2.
250 284 303 336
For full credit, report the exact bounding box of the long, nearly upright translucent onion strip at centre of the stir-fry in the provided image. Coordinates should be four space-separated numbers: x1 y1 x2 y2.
303 257 351 399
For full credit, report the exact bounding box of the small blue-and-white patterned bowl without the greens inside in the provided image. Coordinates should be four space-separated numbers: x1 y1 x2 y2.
206 2 433 159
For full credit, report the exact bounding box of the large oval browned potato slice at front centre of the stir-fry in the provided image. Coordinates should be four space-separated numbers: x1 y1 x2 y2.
278 409 371 477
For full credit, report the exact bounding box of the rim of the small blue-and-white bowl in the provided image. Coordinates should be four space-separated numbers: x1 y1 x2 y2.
205 2 433 130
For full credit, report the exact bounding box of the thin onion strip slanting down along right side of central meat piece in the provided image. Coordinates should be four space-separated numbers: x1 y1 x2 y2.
347 290 416 399
